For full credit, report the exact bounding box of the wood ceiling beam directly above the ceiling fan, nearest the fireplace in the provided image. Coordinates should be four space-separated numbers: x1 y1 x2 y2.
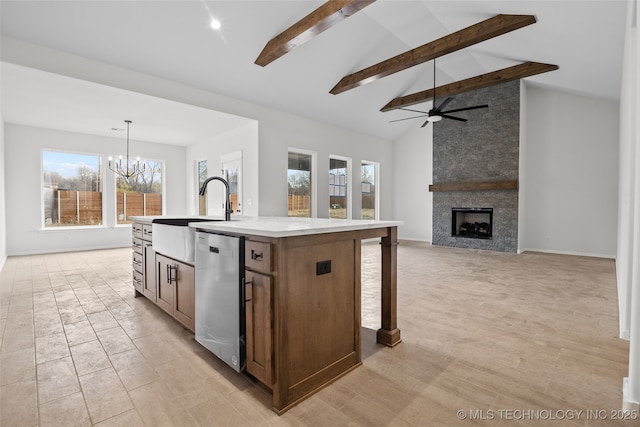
380 61 558 112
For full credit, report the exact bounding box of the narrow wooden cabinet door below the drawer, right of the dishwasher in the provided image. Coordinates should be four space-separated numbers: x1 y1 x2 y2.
245 271 273 386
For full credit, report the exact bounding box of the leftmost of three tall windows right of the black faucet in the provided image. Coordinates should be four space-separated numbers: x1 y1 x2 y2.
287 153 311 217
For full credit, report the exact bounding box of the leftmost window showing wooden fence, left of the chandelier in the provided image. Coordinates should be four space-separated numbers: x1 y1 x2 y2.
42 151 103 228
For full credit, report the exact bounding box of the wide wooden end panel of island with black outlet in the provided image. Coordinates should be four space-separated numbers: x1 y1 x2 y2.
273 236 361 410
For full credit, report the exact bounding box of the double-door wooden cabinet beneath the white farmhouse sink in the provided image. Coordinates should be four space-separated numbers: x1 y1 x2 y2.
156 254 195 331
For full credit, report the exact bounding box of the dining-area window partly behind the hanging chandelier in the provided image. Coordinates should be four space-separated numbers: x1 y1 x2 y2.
116 160 163 224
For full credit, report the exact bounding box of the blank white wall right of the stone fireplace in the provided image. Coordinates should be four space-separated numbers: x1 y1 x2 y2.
519 86 619 258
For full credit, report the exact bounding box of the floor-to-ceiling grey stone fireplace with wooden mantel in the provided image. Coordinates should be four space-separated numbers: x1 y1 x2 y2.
429 81 520 252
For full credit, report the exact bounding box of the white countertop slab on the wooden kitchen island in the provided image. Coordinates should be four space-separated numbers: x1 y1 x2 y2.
189 217 404 237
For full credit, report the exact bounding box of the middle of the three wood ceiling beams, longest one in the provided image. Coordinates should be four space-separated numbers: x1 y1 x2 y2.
329 14 536 95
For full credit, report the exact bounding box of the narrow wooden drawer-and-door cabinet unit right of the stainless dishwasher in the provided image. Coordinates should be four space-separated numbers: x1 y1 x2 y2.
245 240 274 387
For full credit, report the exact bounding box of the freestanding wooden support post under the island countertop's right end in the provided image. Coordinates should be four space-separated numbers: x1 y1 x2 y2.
377 227 402 347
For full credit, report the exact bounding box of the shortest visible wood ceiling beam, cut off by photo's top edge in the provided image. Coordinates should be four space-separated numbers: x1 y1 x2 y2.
255 0 375 67
